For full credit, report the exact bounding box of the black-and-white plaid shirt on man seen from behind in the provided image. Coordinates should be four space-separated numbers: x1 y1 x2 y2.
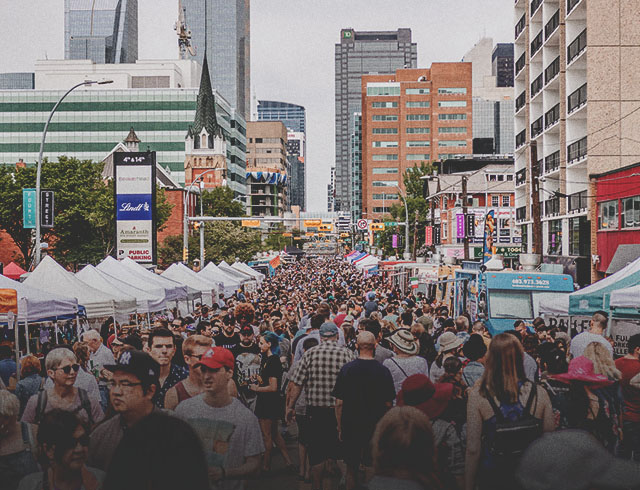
291 340 355 407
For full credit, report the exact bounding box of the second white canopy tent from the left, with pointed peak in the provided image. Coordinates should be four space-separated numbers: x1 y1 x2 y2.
24 255 129 318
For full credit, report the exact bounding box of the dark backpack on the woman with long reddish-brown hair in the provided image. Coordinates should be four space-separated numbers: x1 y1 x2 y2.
488 383 542 461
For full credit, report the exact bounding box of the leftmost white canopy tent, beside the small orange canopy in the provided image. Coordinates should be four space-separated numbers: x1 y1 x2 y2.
0 274 78 322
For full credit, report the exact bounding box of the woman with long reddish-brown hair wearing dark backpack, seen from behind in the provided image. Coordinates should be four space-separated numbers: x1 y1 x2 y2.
465 334 554 490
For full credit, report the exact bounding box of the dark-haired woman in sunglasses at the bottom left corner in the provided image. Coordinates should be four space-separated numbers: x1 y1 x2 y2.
18 409 104 490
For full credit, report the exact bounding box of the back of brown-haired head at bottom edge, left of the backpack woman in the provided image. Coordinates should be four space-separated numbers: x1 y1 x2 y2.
368 406 443 490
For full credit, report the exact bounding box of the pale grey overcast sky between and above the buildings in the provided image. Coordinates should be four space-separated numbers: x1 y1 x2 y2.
0 0 515 211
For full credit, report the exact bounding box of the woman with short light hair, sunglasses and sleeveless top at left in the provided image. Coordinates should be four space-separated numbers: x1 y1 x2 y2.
22 348 104 426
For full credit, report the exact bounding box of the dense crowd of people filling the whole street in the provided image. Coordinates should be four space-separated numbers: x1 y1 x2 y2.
0 258 640 490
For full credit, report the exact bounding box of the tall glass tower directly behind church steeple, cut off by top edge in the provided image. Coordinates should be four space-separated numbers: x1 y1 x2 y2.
182 0 251 118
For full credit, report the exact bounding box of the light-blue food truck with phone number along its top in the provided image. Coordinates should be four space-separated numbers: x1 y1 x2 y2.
454 268 573 335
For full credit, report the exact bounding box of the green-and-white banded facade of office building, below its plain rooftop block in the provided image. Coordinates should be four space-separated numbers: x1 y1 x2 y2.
0 88 246 194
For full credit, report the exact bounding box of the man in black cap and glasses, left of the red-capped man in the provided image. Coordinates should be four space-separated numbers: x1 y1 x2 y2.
88 350 160 470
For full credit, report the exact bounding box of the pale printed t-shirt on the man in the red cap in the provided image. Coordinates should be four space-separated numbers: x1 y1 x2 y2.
176 393 264 490
